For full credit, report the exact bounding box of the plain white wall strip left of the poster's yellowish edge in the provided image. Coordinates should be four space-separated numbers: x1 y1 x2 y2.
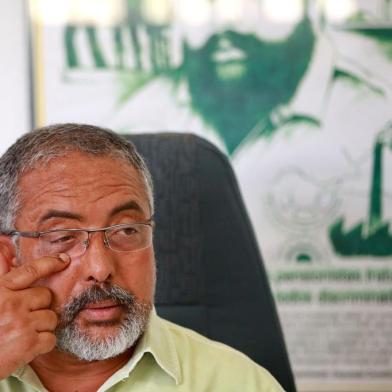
0 0 30 153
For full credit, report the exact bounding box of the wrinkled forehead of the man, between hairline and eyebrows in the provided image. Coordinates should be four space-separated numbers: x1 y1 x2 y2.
18 152 150 221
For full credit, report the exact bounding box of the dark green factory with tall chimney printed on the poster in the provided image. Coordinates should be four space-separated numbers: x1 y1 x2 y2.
329 133 392 256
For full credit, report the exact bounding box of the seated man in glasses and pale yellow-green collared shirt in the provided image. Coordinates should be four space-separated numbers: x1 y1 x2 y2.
0 124 282 392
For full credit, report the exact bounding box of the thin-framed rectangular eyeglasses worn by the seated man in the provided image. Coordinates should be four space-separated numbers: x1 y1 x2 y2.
3 219 153 258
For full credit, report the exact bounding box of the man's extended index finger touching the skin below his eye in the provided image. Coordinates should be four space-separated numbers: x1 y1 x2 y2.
0 253 70 290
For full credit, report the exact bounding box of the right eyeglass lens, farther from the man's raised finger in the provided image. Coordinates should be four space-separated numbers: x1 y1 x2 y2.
106 223 152 252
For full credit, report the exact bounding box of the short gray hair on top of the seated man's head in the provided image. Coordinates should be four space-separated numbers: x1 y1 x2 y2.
0 123 154 232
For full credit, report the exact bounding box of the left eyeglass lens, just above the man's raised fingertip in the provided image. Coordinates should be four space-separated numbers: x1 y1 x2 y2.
39 230 88 257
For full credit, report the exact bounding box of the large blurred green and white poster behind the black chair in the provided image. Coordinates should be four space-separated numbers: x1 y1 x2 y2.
30 0 392 392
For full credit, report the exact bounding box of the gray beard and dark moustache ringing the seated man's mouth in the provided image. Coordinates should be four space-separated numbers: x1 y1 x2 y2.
55 284 152 361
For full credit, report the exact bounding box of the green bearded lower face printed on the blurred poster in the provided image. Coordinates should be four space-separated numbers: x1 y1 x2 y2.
181 1 314 154
